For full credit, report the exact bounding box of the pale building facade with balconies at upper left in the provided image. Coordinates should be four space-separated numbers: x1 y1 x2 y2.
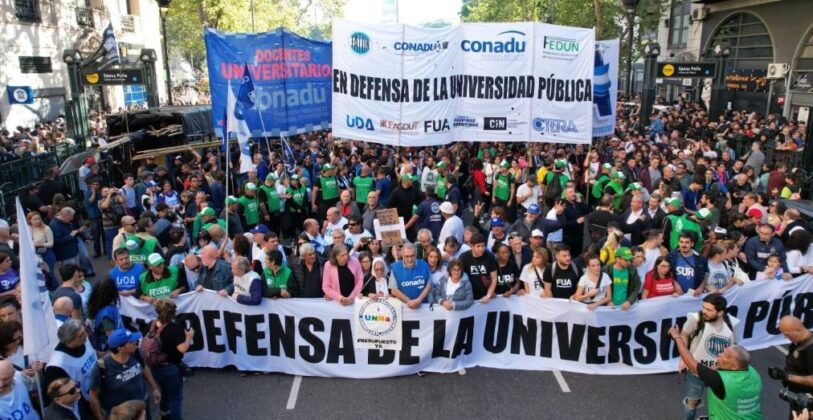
0 0 166 131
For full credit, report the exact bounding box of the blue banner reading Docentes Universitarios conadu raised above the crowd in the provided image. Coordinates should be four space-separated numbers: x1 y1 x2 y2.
203 28 333 137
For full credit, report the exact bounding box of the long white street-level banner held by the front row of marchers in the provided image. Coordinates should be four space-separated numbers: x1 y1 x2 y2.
121 276 813 378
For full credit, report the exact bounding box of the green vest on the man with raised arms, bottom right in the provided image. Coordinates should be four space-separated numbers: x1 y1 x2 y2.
708 366 762 420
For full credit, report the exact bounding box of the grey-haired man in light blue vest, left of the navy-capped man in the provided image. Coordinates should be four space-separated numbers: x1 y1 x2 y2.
44 319 96 418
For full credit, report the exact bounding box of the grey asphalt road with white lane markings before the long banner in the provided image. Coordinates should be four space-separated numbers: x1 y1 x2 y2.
176 348 787 419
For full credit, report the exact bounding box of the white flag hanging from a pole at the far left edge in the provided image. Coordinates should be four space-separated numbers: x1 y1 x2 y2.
17 197 59 360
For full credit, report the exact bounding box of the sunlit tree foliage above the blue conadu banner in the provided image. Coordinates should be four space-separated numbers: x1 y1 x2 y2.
167 0 346 69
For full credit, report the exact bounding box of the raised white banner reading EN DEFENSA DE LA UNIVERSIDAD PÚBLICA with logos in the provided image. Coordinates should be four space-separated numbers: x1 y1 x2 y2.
333 19 595 146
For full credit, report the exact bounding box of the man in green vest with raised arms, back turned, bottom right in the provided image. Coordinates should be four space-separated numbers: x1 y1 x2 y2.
669 325 763 420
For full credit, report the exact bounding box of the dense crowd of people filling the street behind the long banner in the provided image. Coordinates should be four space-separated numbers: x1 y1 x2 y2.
0 96 813 419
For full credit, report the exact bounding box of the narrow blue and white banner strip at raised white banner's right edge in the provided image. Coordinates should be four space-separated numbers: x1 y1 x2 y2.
593 39 621 137
